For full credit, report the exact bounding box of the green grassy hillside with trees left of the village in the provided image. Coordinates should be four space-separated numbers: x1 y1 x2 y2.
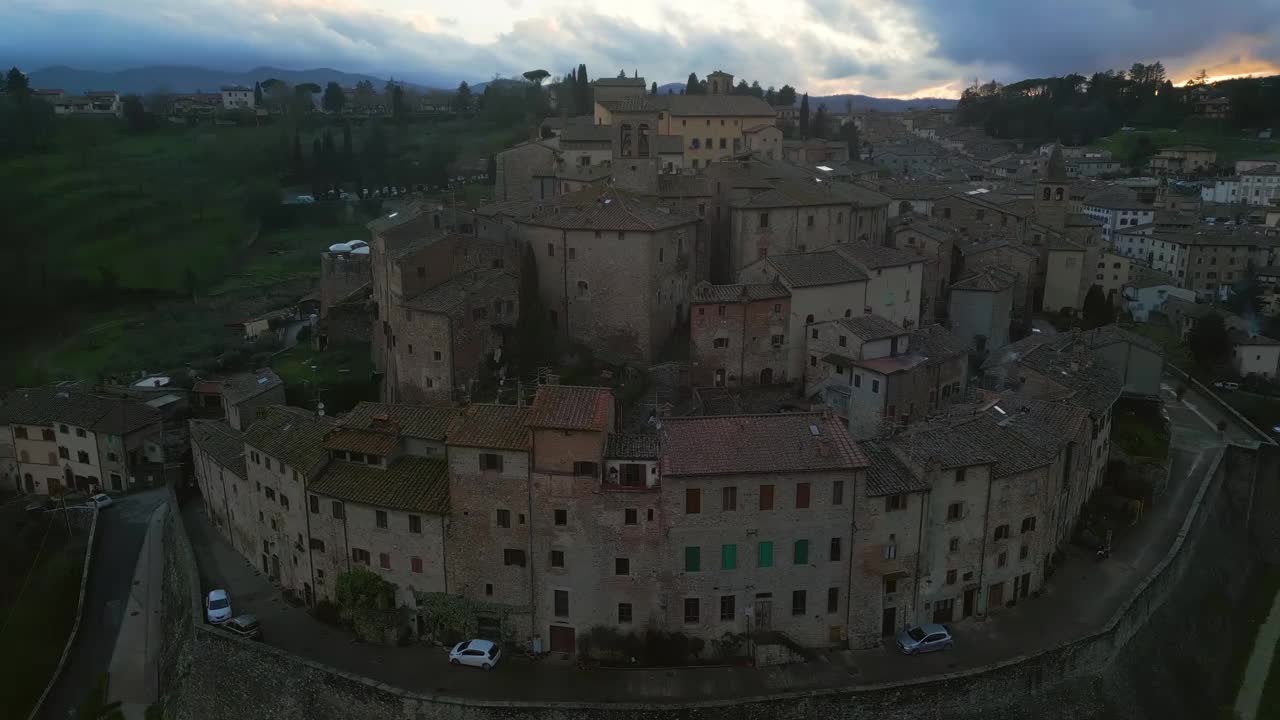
0 118 513 387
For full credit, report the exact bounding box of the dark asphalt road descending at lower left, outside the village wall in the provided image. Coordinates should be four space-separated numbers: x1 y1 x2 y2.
41 489 165 720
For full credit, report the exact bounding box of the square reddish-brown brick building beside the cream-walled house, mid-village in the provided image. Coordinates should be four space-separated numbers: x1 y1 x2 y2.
689 283 792 387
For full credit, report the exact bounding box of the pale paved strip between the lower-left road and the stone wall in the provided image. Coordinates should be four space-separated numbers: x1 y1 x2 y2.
108 505 168 720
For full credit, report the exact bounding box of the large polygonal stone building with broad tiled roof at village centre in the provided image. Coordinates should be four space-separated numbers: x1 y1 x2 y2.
517 190 700 361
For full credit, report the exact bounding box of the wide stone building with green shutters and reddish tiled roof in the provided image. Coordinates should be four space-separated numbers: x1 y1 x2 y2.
660 413 867 646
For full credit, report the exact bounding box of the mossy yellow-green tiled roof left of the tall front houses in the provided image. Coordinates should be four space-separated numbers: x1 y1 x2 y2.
307 455 449 515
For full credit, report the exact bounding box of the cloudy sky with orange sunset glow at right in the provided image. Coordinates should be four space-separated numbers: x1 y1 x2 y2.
0 0 1280 97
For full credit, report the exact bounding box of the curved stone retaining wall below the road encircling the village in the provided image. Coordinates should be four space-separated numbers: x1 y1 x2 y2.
161 448 1280 720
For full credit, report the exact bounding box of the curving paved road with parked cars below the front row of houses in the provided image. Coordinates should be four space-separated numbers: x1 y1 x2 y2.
183 376 1247 702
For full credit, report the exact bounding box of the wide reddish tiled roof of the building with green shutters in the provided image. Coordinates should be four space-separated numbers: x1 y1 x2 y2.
662 413 867 477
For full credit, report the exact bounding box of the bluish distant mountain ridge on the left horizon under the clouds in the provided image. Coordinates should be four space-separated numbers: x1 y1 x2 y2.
31 65 424 95
